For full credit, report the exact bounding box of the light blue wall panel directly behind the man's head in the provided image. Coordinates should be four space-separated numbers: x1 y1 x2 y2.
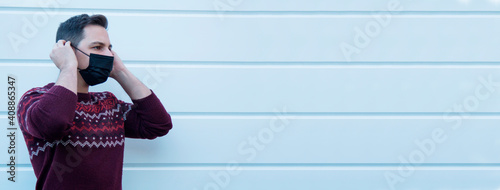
0 11 500 62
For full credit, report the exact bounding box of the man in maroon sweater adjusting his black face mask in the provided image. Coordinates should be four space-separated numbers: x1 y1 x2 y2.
18 14 172 190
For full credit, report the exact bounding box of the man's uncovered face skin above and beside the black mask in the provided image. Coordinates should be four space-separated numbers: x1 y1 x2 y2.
75 25 113 69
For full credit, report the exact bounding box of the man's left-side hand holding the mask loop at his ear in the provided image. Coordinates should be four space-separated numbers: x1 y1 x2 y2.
50 40 78 70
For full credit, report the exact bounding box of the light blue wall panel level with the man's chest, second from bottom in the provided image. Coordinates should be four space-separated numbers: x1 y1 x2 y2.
0 116 500 165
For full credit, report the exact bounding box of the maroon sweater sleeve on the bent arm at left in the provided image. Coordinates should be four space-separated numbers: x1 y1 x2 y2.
18 86 77 140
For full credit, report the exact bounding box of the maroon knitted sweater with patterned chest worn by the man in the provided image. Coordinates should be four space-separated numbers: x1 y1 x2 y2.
18 83 172 190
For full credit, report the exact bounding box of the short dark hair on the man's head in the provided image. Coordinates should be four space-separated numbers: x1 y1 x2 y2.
56 14 108 47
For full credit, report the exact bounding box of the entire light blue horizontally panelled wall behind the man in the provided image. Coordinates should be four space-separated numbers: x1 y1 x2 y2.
0 0 500 190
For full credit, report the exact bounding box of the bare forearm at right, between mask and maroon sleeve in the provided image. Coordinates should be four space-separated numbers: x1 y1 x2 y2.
114 69 151 100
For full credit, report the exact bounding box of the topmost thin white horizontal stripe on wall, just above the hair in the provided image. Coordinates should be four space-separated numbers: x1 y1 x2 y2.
0 8 500 19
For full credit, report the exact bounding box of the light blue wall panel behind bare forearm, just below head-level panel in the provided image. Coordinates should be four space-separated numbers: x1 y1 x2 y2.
0 64 500 114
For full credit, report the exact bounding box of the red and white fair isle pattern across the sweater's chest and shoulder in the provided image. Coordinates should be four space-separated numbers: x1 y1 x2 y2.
18 84 133 160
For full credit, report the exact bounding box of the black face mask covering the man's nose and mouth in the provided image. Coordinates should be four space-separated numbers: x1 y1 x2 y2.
74 47 114 86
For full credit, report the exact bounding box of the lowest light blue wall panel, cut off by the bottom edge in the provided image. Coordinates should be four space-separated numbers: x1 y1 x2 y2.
2 167 500 190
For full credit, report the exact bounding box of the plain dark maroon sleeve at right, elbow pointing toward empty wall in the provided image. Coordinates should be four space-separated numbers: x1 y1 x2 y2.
118 91 172 139
